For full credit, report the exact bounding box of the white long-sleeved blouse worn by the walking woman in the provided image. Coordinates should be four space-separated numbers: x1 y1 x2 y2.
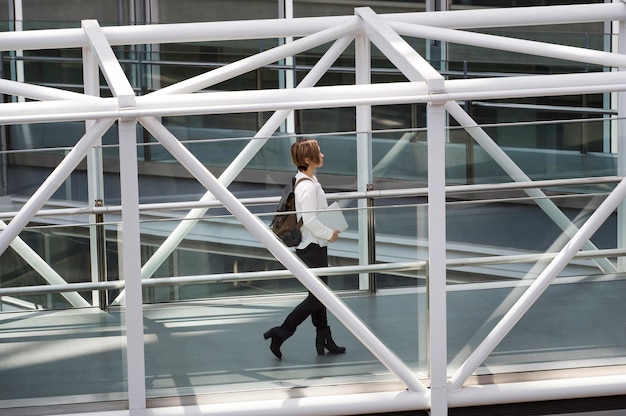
294 172 333 249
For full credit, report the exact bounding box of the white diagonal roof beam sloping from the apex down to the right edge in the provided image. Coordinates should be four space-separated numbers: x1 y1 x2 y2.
389 22 626 67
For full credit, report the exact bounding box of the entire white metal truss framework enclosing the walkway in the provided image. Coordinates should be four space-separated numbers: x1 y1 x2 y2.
0 2 626 416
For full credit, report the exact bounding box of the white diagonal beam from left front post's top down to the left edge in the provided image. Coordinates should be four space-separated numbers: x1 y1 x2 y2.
0 120 115 255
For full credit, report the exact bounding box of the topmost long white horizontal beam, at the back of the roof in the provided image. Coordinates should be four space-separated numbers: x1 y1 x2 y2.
0 2 626 51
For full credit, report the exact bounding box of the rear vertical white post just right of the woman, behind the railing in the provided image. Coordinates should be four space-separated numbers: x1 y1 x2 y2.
354 22 373 290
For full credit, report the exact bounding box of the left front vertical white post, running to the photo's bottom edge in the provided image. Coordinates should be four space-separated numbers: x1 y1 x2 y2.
118 120 146 416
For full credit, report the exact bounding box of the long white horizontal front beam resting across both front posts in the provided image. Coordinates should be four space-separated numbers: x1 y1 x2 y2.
0 72 626 124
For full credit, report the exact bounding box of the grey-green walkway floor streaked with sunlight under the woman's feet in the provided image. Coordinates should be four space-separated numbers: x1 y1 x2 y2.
0 280 626 408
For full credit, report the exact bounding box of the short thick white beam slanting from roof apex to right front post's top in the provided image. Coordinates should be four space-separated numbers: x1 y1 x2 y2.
355 7 444 93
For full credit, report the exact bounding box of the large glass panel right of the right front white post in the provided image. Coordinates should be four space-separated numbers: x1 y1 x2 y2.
447 114 626 376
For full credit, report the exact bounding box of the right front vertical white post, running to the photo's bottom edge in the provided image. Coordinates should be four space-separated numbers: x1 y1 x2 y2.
427 104 448 416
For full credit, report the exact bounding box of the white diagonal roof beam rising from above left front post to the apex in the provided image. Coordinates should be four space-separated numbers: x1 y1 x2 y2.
148 18 359 96
